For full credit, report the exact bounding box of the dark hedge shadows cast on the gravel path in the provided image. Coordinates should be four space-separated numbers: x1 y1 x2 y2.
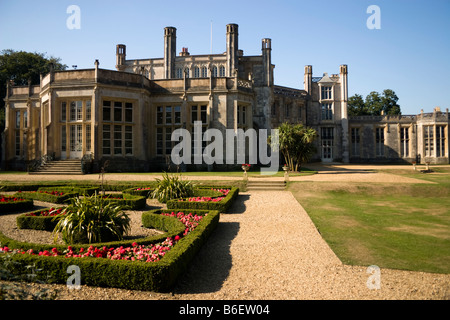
173 191 250 294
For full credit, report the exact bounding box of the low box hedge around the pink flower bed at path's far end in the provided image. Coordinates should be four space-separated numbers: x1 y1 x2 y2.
166 187 239 212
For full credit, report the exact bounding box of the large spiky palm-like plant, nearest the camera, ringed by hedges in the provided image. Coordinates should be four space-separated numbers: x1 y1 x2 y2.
53 193 130 244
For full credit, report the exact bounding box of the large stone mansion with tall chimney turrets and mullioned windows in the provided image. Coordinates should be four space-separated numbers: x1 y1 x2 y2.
1 24 450 171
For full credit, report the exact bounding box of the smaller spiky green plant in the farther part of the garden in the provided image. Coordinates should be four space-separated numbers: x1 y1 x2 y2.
152 172 194 203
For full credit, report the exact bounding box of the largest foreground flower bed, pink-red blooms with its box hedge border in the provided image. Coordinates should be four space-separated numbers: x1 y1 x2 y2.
0 210 220 292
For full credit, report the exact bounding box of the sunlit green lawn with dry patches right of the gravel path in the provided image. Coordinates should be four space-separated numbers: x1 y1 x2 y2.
289 172 450 273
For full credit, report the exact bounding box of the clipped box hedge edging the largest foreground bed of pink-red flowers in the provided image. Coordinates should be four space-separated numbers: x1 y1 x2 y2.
0 210 220 292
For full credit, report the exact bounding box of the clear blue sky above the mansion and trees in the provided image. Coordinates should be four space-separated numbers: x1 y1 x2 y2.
0 0 450 114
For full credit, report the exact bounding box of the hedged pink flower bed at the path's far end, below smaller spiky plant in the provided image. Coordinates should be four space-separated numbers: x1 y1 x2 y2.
167 187 239 212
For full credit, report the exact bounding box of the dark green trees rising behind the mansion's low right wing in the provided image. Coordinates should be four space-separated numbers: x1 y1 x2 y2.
347 89 401 116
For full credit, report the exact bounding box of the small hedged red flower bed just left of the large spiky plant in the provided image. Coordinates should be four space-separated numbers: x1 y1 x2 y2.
16 208 64 231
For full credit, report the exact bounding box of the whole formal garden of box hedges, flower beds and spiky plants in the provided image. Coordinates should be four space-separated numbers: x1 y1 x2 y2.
0 174 239 298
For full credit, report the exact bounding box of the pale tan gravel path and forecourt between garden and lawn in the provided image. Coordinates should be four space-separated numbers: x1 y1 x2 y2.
0 168 450 300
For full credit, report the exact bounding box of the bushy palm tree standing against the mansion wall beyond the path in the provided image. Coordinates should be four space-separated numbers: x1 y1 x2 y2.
271 123 317 171
